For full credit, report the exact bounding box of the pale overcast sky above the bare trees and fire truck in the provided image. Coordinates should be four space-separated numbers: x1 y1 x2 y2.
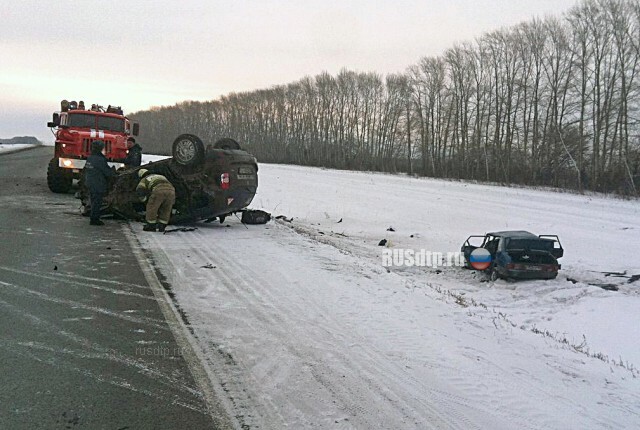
0 0 577 141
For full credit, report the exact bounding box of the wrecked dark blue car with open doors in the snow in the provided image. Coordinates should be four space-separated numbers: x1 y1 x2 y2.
461 230 564 280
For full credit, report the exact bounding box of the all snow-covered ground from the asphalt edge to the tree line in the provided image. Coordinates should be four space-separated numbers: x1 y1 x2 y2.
135 165 640 429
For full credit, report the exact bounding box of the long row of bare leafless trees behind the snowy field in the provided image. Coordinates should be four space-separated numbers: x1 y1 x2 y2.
131 0 640 195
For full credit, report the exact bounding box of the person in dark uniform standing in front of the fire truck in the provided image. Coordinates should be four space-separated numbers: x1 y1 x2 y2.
84 140 116 225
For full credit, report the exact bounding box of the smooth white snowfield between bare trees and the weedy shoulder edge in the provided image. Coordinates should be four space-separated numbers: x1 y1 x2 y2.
254 165 640 368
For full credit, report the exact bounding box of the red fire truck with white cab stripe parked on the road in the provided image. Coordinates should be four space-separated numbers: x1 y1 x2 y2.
47 100 139 193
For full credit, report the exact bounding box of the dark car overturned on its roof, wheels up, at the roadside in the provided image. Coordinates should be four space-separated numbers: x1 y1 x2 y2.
80 134 258 224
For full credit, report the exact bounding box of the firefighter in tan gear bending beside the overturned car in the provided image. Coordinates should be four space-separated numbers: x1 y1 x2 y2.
136 169 176 231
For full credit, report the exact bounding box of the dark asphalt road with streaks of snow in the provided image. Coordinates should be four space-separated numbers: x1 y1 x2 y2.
0 147 215 429
